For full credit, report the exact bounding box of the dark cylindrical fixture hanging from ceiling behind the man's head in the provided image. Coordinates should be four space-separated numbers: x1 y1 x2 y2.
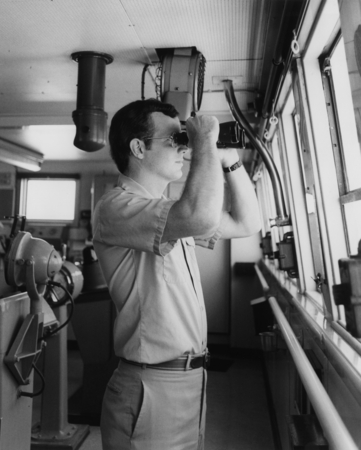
71 51 113 152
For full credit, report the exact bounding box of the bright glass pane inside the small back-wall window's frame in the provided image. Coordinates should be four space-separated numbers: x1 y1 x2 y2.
25 179 76 221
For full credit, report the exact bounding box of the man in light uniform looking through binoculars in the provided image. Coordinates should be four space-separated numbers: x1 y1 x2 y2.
94 100 260 450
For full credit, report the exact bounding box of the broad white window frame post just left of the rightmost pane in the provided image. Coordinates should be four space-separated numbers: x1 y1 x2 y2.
302 0 347 322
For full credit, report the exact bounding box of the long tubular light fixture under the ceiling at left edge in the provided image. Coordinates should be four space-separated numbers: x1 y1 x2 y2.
0 137 44 172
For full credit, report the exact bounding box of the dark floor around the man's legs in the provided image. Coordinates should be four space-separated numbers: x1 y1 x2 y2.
33 350 277 450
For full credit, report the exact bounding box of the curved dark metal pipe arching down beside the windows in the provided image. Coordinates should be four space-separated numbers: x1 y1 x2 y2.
223 80 291 227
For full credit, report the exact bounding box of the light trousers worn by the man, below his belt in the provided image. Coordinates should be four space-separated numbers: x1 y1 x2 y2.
100 361 207 450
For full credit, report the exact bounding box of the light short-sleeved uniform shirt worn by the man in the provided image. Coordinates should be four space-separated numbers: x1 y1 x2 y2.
93 174 221 364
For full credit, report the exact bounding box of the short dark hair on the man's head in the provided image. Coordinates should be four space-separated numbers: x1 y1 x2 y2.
109 98 178 173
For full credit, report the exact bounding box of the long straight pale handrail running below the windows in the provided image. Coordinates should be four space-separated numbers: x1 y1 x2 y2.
255 265 358 450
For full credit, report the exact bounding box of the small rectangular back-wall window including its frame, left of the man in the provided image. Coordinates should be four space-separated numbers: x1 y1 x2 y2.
19 176 78 223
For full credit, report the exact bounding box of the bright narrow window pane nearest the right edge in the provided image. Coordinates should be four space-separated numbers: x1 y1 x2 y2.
331 39 361 191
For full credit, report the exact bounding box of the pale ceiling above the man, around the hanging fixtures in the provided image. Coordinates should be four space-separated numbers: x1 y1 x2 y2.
0 0 292 164
